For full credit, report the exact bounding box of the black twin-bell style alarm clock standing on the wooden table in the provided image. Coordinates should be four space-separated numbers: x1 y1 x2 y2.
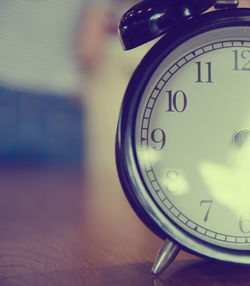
116 0 250 274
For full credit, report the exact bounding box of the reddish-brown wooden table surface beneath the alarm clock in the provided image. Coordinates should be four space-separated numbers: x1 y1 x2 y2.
0 166 250 286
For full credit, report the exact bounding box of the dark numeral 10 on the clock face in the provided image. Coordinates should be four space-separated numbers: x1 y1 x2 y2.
166 90 187 112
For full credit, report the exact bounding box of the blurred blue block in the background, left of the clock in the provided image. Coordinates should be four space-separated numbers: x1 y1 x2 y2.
0 88 84 164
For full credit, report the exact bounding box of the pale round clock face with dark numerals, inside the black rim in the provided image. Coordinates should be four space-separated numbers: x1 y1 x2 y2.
134 26 250 250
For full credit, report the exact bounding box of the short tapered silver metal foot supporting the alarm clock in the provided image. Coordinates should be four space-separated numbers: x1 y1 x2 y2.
152 239 180 275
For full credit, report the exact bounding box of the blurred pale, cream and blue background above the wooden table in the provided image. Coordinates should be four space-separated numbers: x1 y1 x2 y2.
0 0 154 179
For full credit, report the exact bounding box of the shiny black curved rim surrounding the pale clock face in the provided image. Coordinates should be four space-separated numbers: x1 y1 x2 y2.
116 8 250 264
